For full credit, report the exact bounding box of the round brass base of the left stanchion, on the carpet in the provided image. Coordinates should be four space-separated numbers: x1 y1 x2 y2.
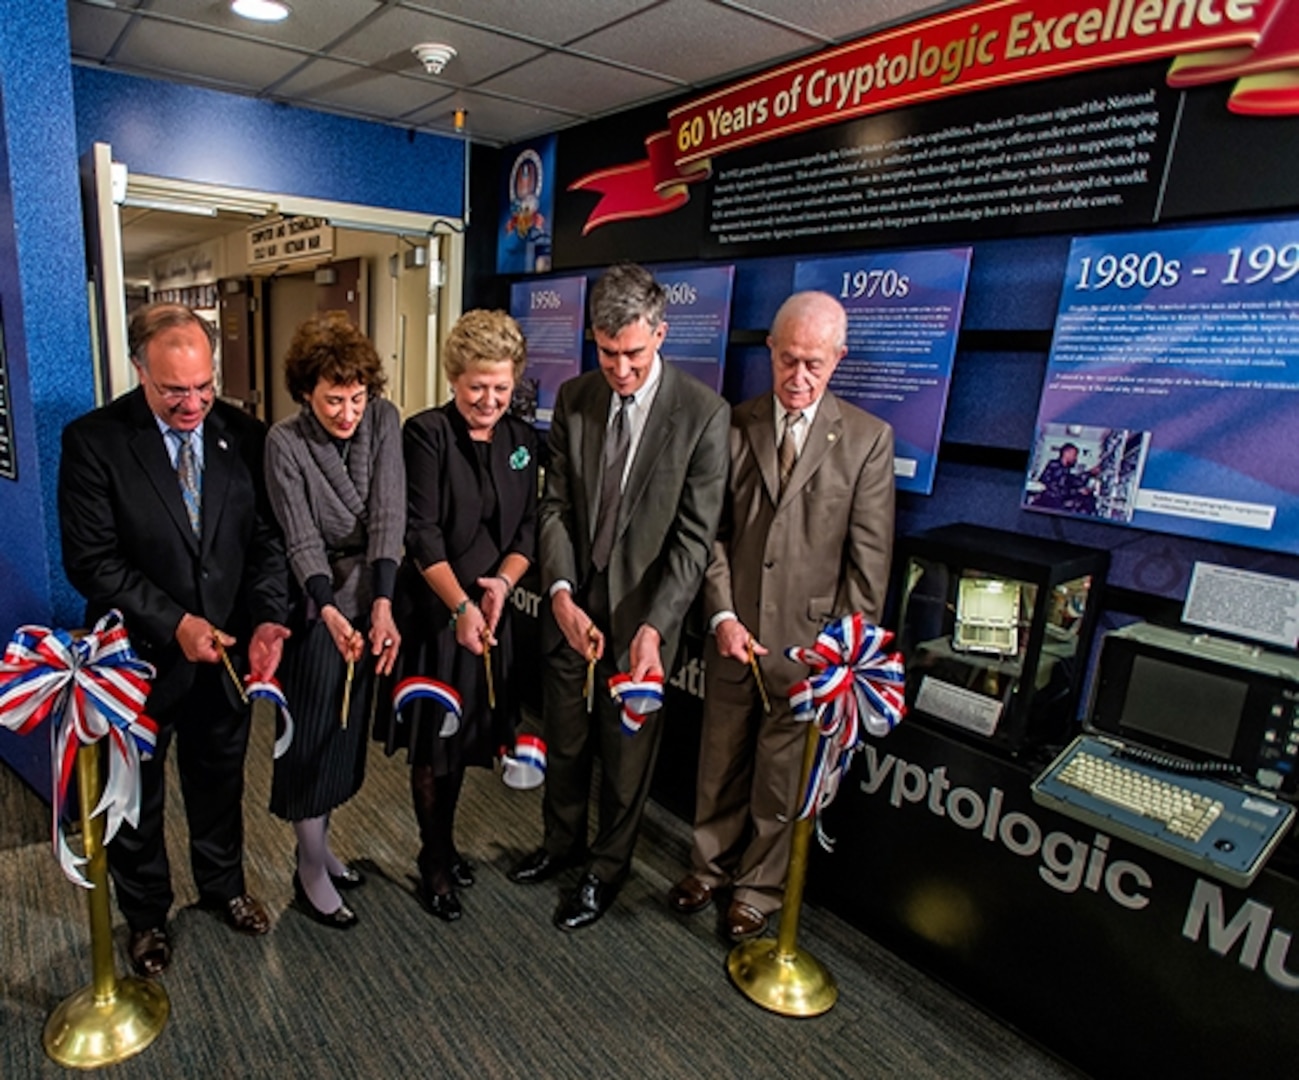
44 976 171 1068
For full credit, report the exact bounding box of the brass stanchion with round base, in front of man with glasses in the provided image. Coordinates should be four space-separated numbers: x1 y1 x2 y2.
44 743 171 1068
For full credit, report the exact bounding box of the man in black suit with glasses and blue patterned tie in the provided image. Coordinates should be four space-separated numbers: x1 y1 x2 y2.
58 304 288 976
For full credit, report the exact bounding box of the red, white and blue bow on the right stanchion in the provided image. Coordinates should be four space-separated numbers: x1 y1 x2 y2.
785 612 907 850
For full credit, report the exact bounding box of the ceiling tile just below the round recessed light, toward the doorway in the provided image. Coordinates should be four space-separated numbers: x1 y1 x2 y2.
109 21 303 91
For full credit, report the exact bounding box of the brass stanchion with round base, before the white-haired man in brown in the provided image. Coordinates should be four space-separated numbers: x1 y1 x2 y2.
726 724 839 1016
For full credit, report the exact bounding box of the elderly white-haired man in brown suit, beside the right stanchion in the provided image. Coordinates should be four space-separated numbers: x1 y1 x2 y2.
668 292 894 941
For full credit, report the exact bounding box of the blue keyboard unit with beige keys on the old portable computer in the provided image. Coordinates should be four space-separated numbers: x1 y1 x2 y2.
1031 734 1295 889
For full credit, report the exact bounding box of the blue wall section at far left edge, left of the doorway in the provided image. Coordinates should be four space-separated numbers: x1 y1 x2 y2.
0 0 94 791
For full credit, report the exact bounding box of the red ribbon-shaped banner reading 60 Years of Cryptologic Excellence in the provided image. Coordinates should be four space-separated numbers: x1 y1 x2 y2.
569 0 1299 235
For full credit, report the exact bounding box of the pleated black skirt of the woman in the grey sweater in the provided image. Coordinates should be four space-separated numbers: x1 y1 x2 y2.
270 620 374 821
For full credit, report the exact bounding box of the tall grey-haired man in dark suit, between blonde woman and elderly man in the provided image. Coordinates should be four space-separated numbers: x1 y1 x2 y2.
511 264 729 929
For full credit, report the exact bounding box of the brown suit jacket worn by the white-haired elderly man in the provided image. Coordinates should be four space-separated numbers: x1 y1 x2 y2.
704 391 894 697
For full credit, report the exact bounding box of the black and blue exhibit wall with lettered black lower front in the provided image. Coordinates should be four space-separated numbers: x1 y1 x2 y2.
469 35 1299 1076
